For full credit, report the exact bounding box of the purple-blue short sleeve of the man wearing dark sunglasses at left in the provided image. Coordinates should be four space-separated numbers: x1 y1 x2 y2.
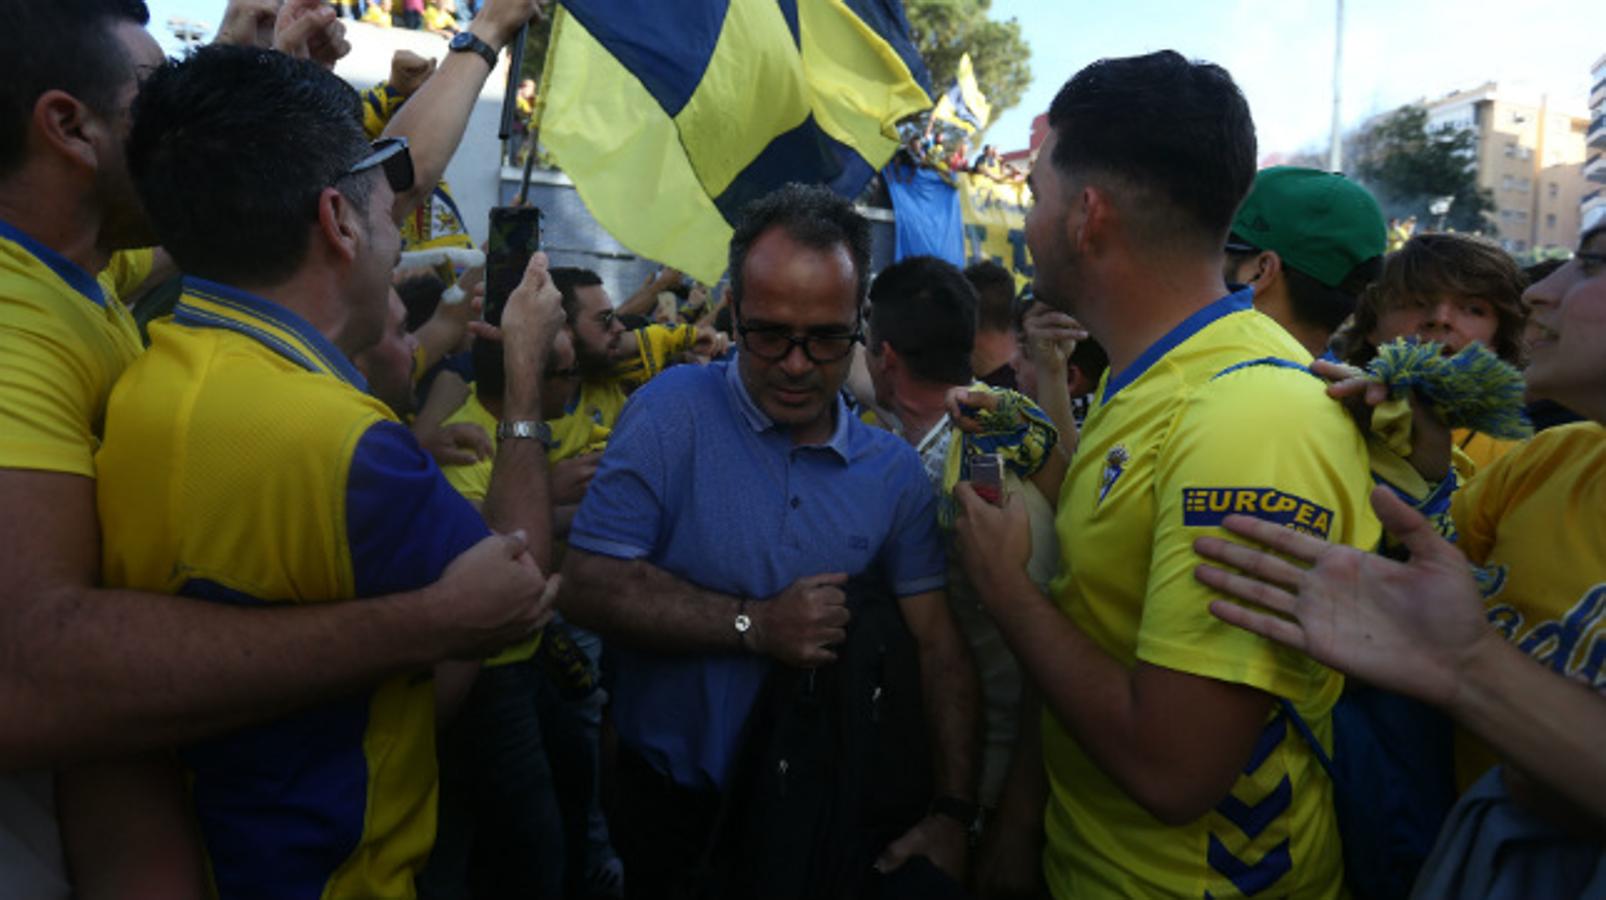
345 421 490 596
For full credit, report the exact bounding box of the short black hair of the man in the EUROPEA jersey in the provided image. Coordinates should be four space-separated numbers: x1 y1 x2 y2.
1049 50 1256 251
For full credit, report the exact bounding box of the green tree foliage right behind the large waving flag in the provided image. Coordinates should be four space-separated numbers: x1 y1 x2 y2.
904 0 1031 121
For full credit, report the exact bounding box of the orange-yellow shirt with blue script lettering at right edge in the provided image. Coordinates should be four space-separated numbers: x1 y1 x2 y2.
1450 423 1606 788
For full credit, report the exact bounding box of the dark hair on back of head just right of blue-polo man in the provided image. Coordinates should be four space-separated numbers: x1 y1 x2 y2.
870 256 976 384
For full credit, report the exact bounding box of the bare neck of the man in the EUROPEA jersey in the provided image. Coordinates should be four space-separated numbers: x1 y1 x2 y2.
1084 257 1227 374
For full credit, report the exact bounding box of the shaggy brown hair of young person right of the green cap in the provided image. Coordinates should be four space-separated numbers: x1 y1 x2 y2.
1335 233 1527 365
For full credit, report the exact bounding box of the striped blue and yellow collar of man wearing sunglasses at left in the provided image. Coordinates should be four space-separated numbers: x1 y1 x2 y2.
173 276 368 392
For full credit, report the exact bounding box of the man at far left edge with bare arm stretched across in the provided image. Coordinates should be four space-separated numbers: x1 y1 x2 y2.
0 0 536 897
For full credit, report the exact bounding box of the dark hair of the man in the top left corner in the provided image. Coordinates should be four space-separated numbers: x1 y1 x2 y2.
0 0 151 177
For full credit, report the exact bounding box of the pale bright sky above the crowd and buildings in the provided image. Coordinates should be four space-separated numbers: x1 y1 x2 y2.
149 0 1606 156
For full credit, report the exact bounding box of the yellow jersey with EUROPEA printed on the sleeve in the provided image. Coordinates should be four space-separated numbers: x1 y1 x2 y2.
1042 291 1380 898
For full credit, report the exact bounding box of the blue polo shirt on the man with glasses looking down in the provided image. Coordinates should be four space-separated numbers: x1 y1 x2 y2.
569 360 948 789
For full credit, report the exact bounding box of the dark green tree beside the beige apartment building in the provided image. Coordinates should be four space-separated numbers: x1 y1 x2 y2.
1346 104 1495 231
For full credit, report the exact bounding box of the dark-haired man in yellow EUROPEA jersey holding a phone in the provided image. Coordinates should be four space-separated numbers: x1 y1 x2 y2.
956 51 1378 898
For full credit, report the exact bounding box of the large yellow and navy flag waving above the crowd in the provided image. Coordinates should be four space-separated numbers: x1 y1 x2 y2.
536 0 931 284
